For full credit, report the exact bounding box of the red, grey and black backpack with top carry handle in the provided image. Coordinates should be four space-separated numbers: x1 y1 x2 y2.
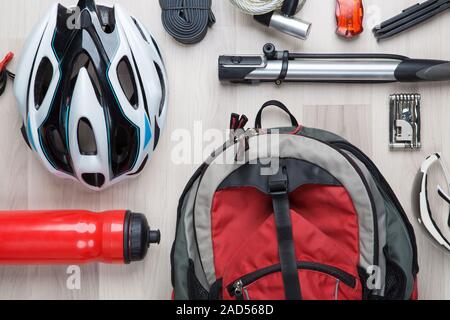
171 101 419 300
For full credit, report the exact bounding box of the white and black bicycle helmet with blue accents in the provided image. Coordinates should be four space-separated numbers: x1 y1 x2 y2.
14 0 167 190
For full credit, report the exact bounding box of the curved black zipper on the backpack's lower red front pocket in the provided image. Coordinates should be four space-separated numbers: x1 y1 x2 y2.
228 262 356 300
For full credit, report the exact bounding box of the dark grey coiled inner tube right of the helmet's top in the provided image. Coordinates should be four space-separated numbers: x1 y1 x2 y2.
159 0 216 44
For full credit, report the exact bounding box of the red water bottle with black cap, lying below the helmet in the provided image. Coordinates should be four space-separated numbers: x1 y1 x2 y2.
0 210 161 264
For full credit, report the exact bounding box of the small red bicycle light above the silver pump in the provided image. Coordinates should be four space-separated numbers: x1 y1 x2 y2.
336 0 364 38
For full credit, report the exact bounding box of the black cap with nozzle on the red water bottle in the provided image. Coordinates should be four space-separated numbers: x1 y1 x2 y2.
124 212 161 263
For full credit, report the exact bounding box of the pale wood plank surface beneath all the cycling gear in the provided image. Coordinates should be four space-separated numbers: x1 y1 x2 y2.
0 0 450 299
